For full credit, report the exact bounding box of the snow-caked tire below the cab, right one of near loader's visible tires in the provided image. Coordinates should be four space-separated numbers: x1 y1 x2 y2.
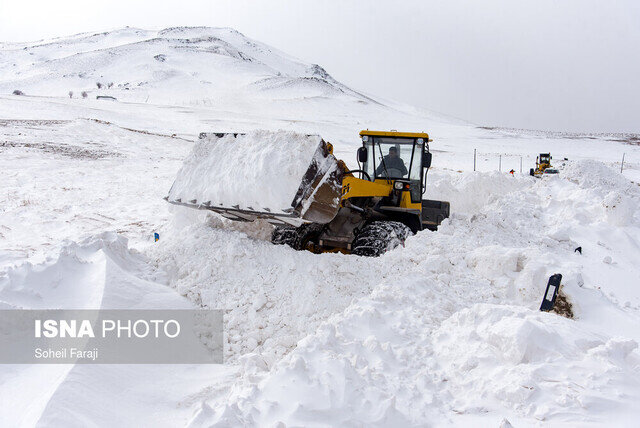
351 221 412 257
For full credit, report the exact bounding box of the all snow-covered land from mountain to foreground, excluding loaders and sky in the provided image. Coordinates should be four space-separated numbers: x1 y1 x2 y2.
0 28 640 427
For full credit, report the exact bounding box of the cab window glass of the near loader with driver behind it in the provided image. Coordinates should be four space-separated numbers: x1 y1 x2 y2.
363 137 423 181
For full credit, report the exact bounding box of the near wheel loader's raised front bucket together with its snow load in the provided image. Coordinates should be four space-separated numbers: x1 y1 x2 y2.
166 131 344 226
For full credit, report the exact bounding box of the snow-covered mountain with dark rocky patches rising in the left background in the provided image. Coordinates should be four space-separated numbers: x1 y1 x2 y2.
0 27 370 103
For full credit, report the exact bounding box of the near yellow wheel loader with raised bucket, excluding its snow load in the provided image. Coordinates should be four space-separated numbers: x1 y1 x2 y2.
166 130 449 256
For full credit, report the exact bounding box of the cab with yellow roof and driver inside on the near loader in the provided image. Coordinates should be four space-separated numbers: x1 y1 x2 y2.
358 131 431 203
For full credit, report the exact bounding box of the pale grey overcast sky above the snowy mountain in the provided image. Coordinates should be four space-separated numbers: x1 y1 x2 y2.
0 0 640 132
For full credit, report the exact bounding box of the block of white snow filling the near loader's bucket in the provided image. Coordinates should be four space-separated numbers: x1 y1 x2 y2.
168 130 322 212
